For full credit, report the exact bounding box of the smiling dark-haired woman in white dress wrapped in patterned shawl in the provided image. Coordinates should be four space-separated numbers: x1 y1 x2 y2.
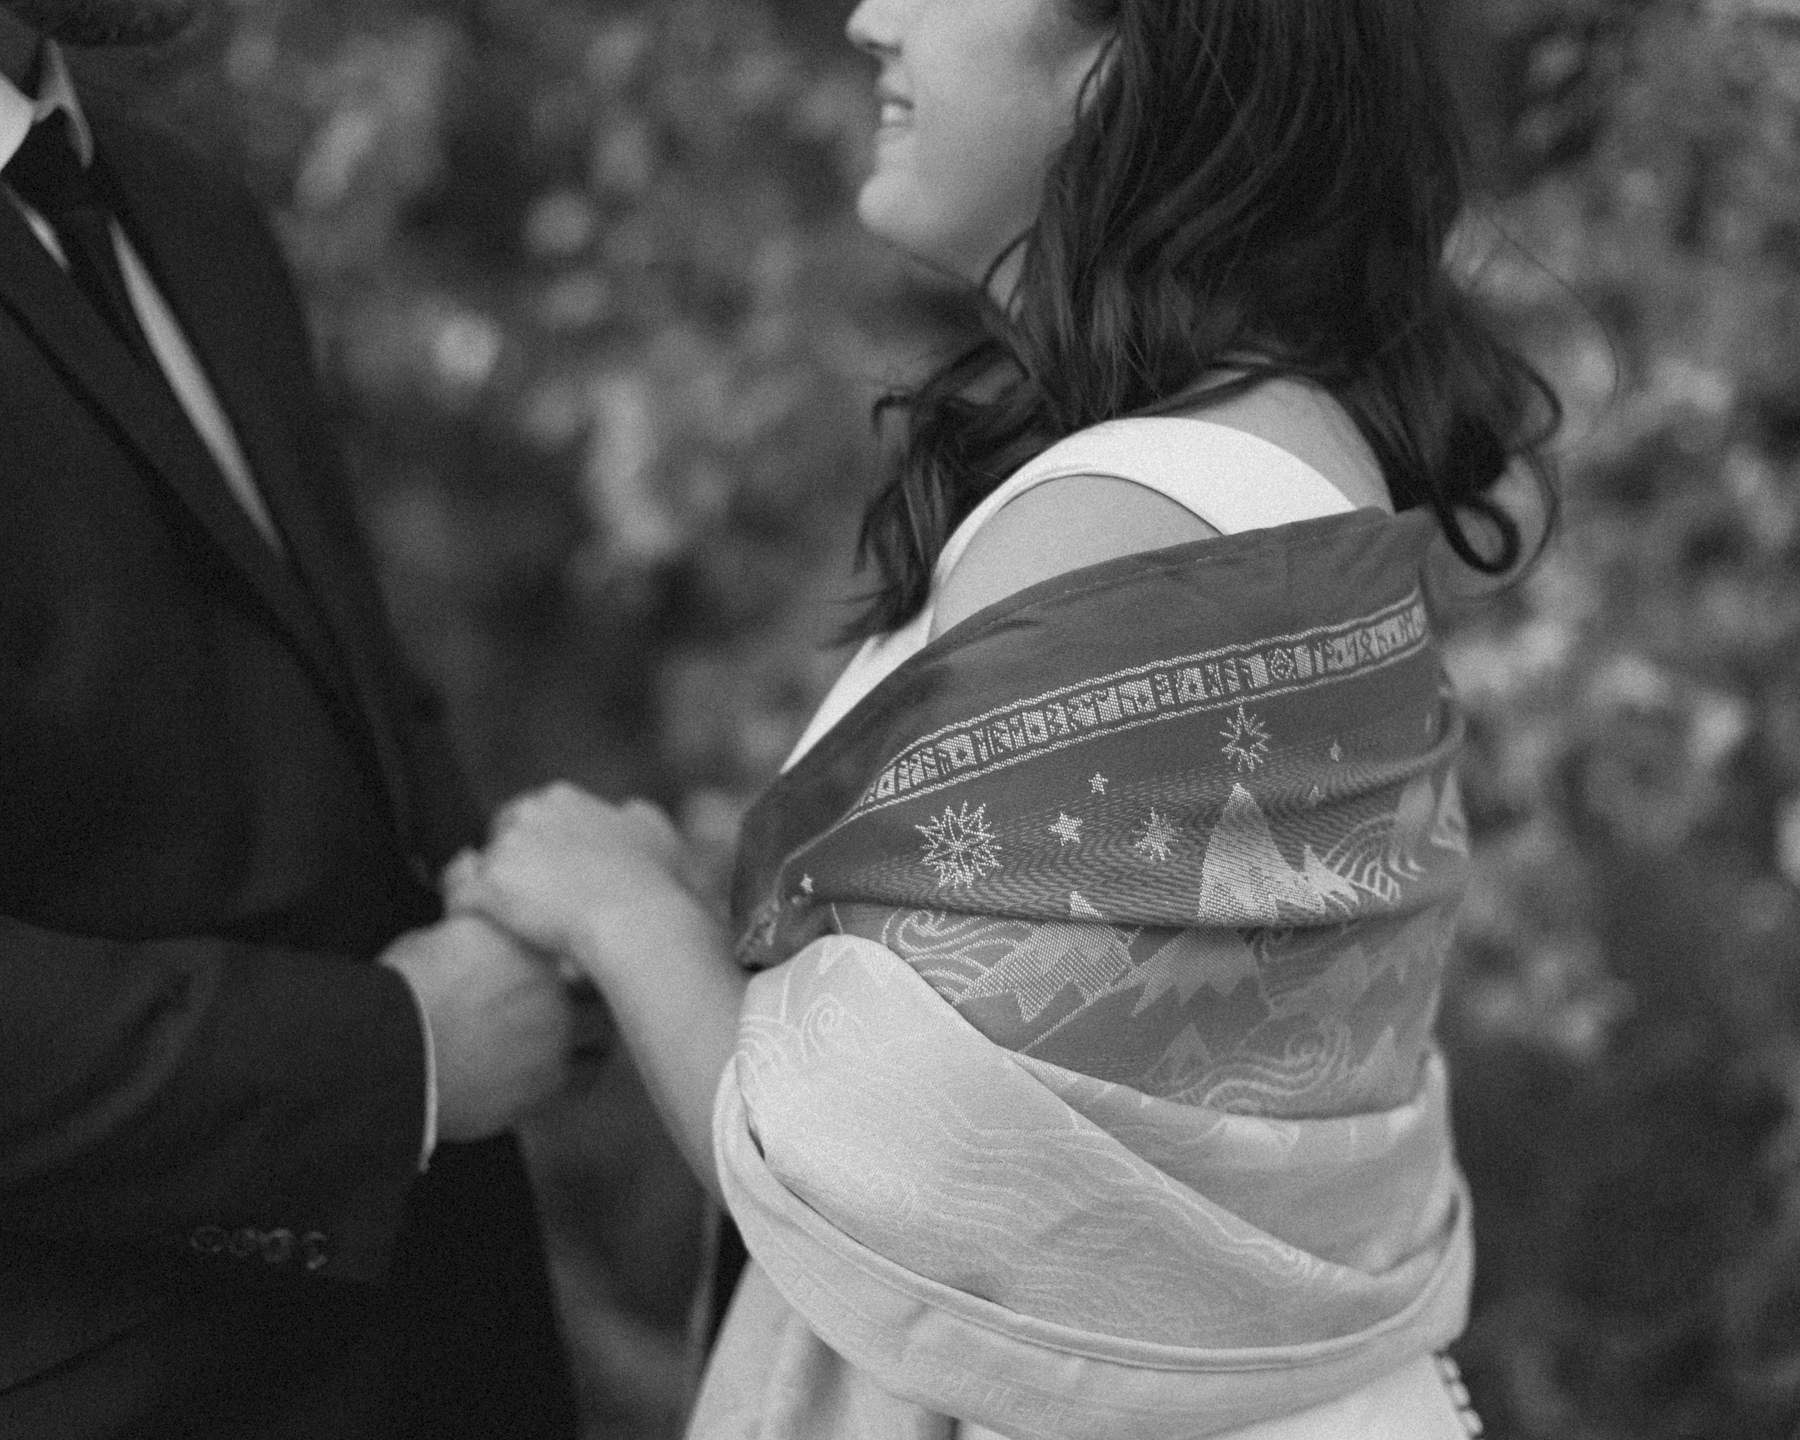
446 0 1555 1440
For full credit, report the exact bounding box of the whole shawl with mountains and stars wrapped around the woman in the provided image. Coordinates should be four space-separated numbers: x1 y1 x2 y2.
689 511 1471 1440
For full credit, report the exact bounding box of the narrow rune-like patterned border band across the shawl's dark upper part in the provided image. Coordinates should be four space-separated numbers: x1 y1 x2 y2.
849 589 1431 830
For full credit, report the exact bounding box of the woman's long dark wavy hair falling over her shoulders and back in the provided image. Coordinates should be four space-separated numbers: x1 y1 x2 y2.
850 0 1561 635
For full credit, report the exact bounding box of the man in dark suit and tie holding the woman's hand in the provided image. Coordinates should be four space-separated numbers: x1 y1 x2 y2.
0 0 574 1440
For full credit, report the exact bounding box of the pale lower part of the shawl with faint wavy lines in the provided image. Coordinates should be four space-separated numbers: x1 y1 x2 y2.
691 936 1469 1440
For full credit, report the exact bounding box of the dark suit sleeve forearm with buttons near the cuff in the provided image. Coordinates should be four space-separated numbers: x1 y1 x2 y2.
0 918 425 1280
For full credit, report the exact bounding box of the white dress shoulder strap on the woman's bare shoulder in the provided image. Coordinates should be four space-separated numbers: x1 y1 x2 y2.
938 416 1355 578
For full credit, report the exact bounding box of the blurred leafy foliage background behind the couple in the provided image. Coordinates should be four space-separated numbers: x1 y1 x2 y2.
81 0 1800 1440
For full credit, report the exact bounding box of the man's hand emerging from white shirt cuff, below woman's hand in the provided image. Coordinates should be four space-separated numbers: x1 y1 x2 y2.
382 914 571 1139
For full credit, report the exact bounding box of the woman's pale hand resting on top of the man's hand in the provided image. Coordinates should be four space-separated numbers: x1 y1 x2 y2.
443 783 715 988
